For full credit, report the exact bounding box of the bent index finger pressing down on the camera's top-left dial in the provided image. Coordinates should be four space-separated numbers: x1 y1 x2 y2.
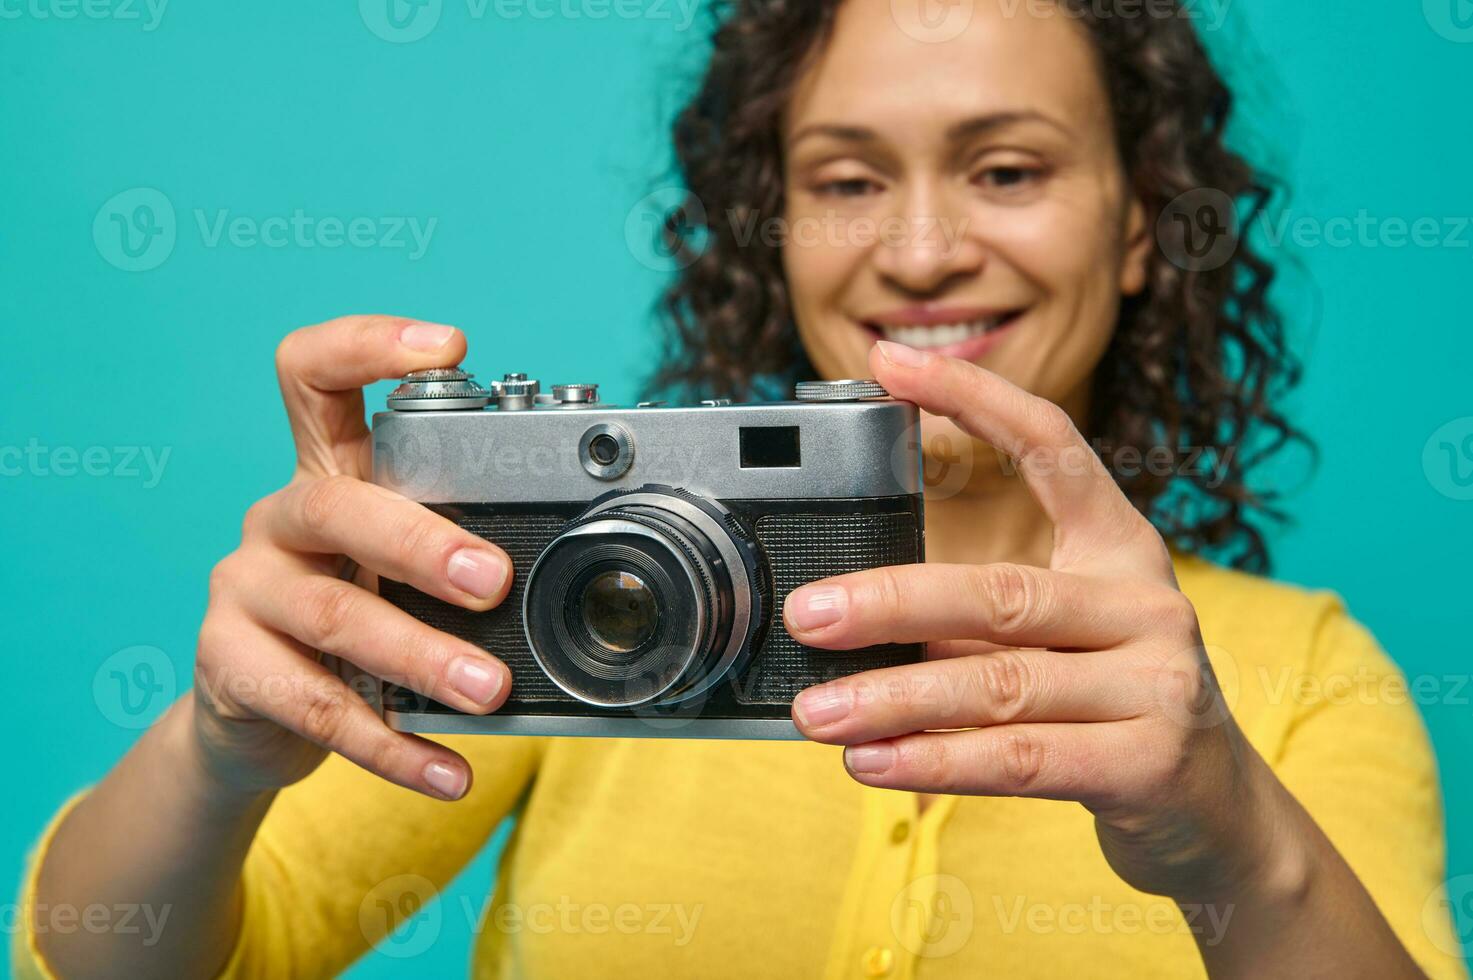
277 317 465 475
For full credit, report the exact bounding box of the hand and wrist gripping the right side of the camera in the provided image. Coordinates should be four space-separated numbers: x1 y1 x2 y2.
784 345 1295 902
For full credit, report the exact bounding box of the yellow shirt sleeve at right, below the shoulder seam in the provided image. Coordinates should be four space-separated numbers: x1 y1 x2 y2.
1264 603 1469 980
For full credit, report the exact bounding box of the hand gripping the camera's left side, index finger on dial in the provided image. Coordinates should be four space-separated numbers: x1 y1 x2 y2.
191 317 513 799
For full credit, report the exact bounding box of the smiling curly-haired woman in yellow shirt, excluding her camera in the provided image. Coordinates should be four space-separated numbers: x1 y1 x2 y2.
18 0 1463 977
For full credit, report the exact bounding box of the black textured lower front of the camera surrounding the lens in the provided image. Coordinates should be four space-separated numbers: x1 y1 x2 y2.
380 495 925 737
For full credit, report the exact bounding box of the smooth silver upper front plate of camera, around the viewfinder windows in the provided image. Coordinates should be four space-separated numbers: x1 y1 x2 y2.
373 401 921 504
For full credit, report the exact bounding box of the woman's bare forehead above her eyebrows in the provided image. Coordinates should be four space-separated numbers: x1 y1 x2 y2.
787 0 1106 139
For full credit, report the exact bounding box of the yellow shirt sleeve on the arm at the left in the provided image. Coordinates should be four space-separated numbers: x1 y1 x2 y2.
12 737 544 980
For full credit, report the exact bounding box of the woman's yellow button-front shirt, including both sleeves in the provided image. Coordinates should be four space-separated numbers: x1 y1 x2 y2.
15 559 1467 980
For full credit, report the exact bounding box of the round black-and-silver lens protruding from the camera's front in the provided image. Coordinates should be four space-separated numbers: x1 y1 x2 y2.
521 488 762 707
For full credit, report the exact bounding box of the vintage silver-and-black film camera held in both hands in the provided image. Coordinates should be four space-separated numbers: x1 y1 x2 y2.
373 370 924 738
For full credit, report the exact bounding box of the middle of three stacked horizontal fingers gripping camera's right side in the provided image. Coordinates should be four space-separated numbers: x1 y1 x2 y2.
792 650 1153 746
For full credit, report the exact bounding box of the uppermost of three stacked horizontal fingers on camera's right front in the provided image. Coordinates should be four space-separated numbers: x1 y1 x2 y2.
782 563 1186 650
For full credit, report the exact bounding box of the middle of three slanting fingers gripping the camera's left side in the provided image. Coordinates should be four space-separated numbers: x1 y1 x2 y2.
229 554 511 715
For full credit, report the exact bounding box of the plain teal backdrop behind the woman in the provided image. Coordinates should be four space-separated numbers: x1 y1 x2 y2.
0 0 1473 977
